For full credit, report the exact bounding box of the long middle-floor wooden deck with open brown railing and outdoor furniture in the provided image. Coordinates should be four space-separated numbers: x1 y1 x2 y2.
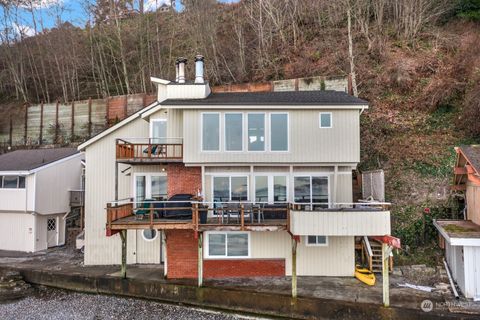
106 199 291 236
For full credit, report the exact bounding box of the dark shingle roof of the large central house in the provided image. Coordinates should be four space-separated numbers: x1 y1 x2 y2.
162 90 368 106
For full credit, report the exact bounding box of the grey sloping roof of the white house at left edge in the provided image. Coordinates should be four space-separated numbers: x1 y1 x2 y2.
0 148 78 171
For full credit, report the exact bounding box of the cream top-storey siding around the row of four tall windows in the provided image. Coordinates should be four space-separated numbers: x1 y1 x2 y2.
183 109 360 163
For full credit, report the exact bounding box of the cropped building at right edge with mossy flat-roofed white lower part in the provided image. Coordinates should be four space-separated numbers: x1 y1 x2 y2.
434 145 480 299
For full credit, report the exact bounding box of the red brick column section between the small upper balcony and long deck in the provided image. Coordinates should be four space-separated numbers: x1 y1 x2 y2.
167 163 202 197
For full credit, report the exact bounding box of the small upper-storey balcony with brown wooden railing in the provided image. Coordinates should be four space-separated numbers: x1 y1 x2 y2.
116 138 183 164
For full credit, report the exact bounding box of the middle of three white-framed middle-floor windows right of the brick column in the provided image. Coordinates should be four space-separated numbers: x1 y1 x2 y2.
255 175 287 203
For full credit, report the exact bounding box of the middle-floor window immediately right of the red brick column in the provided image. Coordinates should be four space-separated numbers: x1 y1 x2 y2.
213 176 248 202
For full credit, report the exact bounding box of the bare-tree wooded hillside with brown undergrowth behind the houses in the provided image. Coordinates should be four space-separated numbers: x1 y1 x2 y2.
0 0 480 261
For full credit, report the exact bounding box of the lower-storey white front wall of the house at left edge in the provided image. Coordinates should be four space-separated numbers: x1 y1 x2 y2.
0 212 35 252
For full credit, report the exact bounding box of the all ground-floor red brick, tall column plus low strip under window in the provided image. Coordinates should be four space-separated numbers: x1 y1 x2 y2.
165 230 285 279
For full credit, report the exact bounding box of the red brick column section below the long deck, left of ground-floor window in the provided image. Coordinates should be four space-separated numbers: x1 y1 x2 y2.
165 230 198 279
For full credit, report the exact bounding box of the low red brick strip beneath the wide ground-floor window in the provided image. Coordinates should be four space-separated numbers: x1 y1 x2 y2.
203 259 285 279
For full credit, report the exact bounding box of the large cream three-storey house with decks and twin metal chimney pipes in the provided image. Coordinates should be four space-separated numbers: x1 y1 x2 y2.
79 58 390 278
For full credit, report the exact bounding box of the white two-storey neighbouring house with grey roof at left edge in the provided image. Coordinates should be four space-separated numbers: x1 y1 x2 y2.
0 148 83 252
